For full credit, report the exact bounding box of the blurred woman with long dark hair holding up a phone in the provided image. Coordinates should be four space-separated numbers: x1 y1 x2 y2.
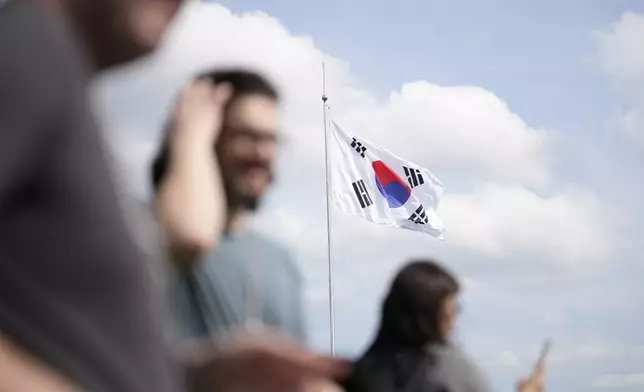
346 261 545 392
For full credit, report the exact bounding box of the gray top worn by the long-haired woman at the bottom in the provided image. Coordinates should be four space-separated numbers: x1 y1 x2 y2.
420 345 489 392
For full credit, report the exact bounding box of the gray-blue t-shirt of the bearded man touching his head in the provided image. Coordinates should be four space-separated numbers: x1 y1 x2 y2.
174 233 306 342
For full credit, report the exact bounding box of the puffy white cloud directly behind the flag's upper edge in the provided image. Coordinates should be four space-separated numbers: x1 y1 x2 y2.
340 81 549 186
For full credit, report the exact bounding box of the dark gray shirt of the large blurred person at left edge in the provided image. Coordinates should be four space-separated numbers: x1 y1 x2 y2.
0 0 176 392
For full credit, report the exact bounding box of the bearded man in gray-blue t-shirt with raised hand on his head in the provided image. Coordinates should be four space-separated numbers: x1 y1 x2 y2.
152 70 305 342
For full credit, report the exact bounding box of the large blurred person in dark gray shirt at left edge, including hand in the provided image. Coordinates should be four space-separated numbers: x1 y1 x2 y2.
0 0 348 392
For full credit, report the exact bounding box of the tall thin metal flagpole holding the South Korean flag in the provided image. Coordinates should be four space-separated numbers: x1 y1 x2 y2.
322 61 335 356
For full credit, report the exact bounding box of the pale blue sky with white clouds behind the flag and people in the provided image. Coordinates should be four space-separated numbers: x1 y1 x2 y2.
93 0 644 392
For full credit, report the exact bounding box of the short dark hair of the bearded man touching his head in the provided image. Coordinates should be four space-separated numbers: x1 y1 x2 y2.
151 69 280 192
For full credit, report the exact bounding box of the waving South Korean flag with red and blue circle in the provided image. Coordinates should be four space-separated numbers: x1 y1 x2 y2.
331 121 445 239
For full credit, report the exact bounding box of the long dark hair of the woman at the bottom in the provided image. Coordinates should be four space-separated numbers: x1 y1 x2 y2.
346 260 459 392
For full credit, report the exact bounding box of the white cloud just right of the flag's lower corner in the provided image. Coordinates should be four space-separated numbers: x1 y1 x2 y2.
440 184 615 268
